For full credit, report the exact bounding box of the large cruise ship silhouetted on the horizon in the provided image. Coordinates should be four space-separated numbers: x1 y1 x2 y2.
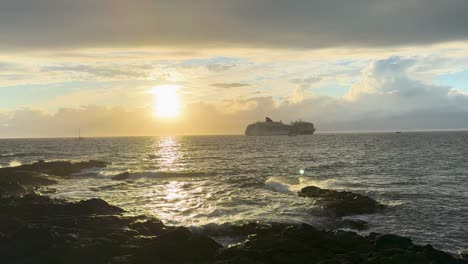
245 117 315 136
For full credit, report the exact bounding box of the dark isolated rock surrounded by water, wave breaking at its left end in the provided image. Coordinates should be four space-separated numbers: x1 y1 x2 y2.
299 186 384 216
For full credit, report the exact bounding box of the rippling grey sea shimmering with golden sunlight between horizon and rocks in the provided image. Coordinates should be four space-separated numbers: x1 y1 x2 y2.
0 132 468 252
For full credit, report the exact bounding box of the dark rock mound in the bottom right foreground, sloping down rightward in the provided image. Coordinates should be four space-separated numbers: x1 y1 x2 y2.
216 224 467 264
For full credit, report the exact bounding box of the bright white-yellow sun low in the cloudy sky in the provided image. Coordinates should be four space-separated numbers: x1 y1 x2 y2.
152 85 180 118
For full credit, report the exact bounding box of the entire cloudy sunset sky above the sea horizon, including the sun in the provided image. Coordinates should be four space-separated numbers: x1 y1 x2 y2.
0 0 468 137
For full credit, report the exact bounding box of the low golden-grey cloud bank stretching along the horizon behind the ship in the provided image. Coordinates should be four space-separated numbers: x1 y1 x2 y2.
0 57 468 137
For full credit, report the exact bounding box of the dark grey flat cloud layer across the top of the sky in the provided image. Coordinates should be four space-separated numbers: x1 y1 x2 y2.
0 0 468 49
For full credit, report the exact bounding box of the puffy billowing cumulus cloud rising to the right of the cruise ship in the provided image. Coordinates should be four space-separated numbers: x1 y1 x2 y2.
344 57 468 116
